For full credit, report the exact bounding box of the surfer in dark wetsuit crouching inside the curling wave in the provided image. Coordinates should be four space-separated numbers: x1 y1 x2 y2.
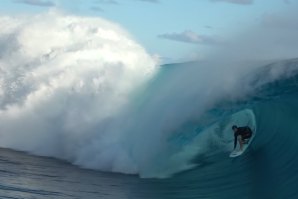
232 125 252 151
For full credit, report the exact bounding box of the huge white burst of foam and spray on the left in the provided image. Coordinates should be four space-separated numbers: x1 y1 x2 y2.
0 12 156 173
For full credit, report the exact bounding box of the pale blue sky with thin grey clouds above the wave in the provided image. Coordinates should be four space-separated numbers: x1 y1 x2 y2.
0 0 298 63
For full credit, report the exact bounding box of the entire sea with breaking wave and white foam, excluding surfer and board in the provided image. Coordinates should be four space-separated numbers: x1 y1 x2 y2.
0 12 298 198
